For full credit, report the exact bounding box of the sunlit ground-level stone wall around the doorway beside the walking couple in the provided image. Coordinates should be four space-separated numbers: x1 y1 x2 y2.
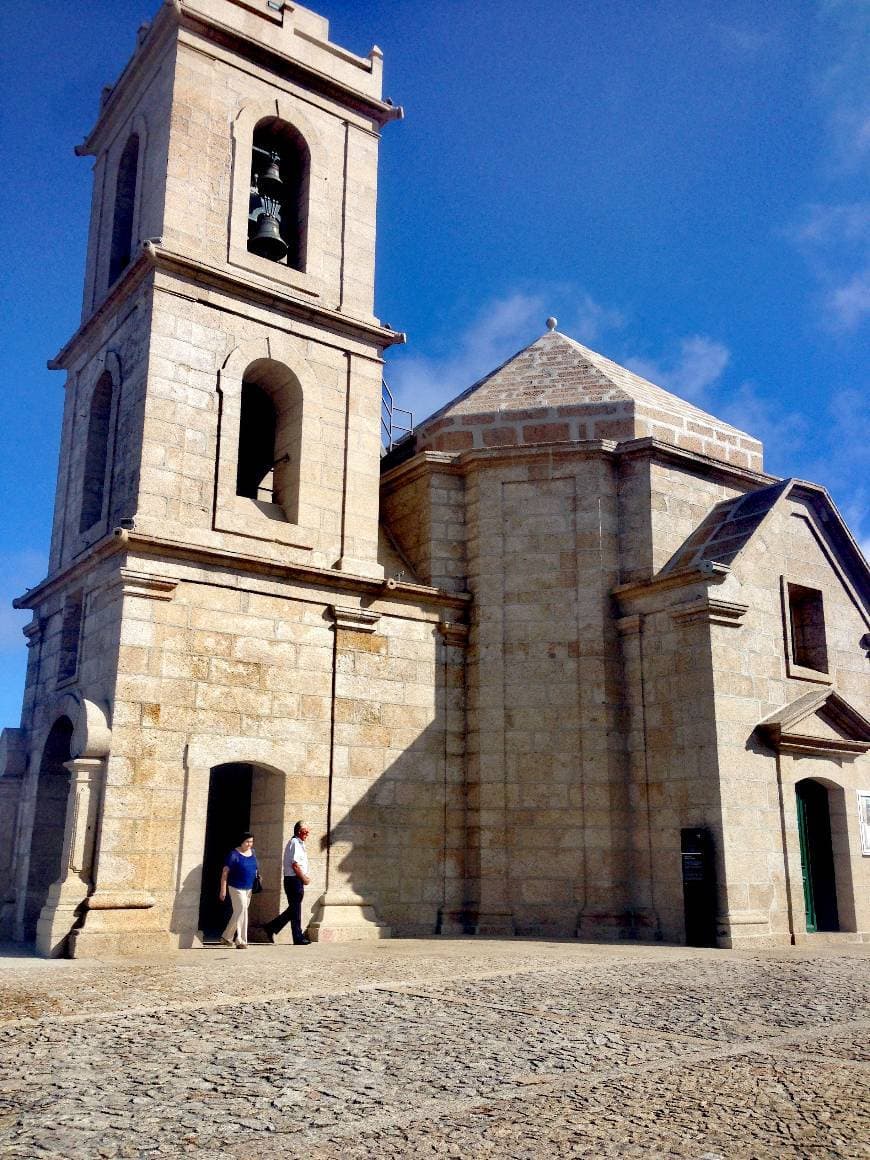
65 560 464 950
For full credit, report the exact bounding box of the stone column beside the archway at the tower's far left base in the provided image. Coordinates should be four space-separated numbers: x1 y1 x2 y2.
36 757 106 958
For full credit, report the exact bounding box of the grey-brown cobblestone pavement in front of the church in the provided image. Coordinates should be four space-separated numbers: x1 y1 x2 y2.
0 940 870 1160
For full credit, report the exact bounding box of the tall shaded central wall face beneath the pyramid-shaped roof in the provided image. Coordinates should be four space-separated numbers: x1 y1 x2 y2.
466 447 624 934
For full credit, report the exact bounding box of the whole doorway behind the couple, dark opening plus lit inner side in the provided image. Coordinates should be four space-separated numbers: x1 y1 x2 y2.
200 762 284 942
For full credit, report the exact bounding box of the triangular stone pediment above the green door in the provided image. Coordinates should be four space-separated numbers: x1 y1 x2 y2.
755 689 870 757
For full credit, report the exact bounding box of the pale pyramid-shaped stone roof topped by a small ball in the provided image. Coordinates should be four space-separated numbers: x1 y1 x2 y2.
416 331 762 471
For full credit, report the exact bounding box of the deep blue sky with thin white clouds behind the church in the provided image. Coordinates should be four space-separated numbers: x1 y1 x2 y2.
0 0 870 725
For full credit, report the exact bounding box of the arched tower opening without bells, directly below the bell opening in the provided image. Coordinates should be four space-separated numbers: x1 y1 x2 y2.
235 358 302 522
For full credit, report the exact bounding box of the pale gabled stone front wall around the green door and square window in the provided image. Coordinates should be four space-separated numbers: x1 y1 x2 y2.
713 499 870 940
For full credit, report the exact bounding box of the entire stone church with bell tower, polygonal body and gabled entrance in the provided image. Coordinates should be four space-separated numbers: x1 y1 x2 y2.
0 0 870 956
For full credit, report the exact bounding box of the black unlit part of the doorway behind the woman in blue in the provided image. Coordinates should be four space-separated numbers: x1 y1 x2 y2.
200 763 253 942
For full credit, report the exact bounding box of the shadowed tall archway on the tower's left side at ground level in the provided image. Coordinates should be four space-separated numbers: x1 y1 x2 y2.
24 717 73 942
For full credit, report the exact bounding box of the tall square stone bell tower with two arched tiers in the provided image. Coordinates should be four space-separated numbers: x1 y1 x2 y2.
0 0 412 954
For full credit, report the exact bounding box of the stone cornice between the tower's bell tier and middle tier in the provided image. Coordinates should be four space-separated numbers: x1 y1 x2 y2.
49 241 406 370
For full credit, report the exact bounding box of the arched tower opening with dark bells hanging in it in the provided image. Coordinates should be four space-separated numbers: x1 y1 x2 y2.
247 117 311 270
